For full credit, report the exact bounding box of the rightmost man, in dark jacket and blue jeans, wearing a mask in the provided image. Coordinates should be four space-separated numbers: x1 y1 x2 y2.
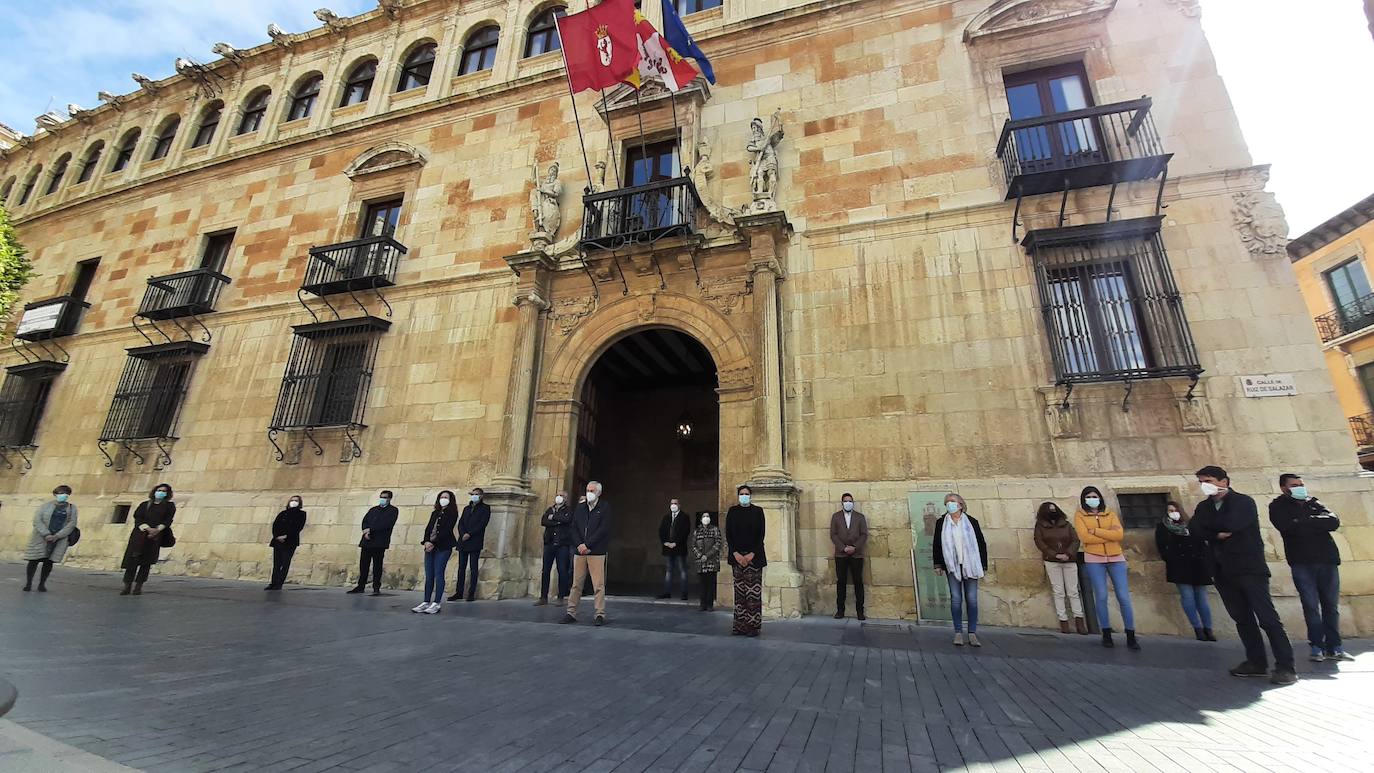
1270 472 1355 663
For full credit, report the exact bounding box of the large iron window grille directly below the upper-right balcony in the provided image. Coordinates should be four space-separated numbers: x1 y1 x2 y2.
1022 217 1202 384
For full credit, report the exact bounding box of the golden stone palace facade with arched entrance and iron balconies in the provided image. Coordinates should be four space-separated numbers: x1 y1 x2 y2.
0 0 1374 632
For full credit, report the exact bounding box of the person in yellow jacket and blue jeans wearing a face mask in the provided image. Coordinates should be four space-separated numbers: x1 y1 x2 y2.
1073 486 1140 649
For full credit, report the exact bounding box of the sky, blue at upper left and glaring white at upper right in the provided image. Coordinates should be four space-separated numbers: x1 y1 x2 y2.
0 0 1374 235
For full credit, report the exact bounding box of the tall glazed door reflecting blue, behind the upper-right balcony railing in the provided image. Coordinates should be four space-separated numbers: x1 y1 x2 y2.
1006 63 1107 172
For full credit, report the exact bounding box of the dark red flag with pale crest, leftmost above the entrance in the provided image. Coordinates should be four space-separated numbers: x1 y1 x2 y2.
558 0 640 93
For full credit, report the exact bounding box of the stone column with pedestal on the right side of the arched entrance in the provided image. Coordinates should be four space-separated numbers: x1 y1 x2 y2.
735 211 805 618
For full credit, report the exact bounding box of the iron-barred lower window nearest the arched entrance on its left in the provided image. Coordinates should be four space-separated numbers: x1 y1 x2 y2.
271 317 390 430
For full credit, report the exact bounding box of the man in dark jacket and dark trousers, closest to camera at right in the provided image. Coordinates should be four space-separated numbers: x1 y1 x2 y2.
1189 464 1297 685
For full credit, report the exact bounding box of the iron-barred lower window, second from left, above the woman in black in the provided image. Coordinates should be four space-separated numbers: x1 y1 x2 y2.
100 342 201 441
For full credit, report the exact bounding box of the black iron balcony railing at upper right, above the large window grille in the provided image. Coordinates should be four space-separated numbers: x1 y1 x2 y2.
998 97 1172 199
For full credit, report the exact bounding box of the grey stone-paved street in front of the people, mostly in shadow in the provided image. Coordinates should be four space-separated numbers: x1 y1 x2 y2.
0 564 1374 773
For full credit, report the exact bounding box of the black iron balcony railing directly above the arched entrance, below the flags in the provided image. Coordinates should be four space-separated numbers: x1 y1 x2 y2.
583 177 701 250
